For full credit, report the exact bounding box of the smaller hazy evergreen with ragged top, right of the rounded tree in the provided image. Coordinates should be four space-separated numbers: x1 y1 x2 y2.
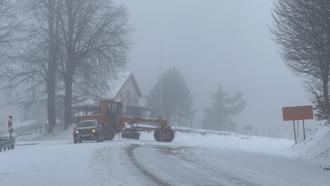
203 85 246 131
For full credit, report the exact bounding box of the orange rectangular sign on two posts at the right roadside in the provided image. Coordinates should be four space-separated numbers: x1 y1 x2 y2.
282 105 314 144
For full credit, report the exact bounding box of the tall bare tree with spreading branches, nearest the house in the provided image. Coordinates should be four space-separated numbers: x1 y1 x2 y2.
58 0 128 128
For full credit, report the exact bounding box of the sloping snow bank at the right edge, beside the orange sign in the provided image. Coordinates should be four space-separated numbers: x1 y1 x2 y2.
295 126 330 170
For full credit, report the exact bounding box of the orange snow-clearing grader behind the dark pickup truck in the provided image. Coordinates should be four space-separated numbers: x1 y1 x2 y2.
79 99 175 142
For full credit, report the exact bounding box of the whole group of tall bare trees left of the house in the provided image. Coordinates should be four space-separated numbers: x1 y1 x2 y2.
0 0 129 132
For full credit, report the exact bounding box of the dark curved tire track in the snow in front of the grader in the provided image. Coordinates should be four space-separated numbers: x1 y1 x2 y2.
127 144 171 186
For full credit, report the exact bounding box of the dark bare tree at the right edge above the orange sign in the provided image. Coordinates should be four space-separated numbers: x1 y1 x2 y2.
272 0 330 119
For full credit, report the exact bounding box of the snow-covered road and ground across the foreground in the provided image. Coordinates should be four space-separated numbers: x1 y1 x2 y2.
0 130 330 186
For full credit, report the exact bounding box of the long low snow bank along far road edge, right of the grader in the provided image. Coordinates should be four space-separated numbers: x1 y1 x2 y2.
141 127 294 157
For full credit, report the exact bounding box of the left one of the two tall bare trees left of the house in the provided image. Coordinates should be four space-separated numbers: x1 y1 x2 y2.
0 0 60 132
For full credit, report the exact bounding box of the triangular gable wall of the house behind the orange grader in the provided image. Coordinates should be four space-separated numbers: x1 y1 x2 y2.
115 76 140 106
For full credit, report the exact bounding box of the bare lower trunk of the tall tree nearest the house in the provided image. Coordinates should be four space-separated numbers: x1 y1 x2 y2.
64 73 73 129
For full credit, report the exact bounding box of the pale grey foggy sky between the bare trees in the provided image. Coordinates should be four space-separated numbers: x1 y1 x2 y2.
123 0 310 130
